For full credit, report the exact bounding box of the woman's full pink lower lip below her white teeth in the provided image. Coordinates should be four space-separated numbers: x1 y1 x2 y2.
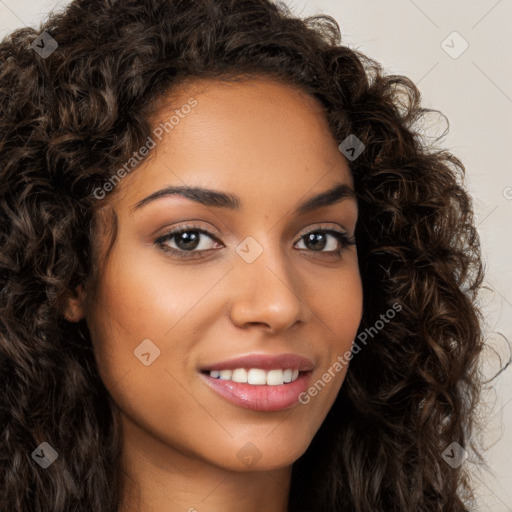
201 371 311 412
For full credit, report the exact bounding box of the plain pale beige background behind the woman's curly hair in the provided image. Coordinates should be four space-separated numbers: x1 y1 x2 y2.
0 0 512 512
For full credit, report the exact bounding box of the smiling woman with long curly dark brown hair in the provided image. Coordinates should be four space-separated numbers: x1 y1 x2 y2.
0 0 483 512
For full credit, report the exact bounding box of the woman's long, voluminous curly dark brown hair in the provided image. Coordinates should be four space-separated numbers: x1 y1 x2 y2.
0 0 483 512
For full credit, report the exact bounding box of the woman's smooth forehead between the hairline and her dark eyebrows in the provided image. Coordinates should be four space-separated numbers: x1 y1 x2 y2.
110 78 352 210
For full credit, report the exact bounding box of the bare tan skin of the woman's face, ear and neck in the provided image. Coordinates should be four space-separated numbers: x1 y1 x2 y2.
67 77 363 512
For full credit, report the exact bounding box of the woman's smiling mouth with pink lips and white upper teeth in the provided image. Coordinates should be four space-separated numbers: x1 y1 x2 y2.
200 354 313 412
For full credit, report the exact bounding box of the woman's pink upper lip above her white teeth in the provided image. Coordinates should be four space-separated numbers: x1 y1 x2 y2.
201 354 314 371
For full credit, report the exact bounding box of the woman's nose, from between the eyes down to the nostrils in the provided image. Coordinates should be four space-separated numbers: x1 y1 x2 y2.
230 240 312 333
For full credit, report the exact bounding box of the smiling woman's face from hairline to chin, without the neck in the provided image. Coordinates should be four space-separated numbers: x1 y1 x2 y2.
72 79 362 471
